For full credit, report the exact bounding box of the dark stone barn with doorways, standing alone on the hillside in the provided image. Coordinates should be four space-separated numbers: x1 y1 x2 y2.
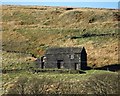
40 47 87 70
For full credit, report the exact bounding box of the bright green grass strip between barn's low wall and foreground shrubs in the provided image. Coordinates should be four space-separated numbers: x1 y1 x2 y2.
2 70 114 83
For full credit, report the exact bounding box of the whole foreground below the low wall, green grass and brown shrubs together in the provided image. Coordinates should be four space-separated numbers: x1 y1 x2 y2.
3 70 118 94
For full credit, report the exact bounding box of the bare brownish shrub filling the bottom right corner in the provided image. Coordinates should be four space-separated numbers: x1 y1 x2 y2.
85 73 119 95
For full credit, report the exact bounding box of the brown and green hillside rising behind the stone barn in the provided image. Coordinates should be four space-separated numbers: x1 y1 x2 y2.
0 5 119 67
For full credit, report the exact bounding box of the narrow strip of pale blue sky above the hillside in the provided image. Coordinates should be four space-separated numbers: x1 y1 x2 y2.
1 0 120 9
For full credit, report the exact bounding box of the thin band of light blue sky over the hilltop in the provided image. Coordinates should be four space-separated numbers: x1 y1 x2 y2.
2 2 120 9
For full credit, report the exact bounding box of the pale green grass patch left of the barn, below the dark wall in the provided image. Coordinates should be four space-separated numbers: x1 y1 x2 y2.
2 51 35 70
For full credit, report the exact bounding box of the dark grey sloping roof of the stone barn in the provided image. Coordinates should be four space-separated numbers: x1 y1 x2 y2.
45 47 84 54
